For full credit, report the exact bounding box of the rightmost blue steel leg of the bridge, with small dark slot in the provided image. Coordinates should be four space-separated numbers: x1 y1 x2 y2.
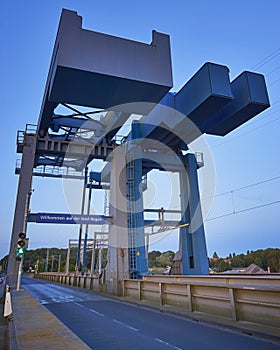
180 153 209 275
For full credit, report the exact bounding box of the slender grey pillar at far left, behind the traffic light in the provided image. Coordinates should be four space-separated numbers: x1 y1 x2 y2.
7 134 36 288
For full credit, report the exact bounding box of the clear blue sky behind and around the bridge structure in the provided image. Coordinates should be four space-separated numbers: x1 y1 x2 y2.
0 0 280 257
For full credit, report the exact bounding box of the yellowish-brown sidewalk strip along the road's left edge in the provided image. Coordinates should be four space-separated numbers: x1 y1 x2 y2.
8 290 90 350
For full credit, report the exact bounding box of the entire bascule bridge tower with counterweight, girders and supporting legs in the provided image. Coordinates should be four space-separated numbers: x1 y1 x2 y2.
8 10 269 293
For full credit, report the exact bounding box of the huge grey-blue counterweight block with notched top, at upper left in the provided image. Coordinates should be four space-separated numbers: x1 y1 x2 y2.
38 10 173 137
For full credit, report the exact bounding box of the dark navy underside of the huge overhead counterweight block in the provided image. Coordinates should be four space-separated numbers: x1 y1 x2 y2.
50 67 172 112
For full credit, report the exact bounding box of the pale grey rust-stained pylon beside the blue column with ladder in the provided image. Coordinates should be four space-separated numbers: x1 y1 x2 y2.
106 146 129 295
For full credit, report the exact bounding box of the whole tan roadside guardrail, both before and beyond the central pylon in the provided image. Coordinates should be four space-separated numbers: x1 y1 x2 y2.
34 273 280 329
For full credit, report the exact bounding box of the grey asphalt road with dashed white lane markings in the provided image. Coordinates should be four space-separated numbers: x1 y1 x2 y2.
22 277 280 350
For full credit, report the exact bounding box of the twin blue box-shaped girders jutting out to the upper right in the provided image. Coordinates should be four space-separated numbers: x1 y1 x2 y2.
128 62 270 152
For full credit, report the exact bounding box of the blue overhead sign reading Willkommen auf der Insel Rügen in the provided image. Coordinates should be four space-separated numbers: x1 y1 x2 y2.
36 213 105 225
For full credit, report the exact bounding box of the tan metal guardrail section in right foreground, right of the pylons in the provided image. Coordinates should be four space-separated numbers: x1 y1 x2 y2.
123 276 280 327
